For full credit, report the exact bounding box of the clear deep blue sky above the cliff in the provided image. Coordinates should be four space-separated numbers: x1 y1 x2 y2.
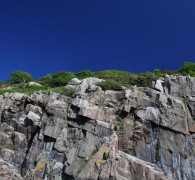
0 0 195 80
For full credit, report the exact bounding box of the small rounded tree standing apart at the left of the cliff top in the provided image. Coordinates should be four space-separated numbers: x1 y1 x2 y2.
8 71 34 84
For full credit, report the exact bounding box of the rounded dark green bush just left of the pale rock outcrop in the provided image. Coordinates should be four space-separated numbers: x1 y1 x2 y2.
51 71 75 86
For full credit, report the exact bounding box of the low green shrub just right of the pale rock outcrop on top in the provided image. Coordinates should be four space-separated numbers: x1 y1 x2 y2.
96 79 122 91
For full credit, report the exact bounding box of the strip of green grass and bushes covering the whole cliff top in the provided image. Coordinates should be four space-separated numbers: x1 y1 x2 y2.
0 62 195 95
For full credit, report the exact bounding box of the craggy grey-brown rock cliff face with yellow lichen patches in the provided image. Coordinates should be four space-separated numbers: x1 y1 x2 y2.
0 76 195 180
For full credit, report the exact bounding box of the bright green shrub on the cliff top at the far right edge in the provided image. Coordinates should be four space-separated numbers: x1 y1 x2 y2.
179 62 195 77
